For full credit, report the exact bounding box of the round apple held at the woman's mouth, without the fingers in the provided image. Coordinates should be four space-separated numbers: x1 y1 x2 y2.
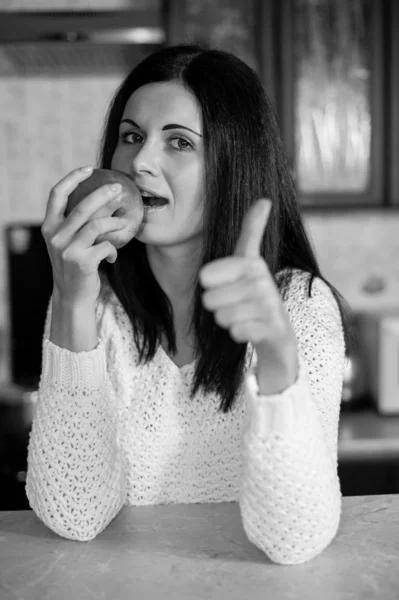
64 169 144 250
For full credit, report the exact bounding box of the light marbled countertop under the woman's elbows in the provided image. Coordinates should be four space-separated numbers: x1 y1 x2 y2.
0 494 399 600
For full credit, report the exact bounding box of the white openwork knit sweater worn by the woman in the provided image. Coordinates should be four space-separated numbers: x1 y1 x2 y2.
26 271 345 564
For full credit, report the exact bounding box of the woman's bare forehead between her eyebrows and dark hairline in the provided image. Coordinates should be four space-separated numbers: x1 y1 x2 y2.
123 81 202 129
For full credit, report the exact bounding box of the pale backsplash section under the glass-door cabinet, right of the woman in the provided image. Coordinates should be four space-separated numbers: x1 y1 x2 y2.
305 209 399 312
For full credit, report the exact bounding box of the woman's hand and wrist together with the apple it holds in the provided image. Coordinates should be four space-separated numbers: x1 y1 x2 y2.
41 167 144 310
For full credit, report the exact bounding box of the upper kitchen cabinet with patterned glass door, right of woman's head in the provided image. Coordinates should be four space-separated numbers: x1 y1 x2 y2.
167 0 399 211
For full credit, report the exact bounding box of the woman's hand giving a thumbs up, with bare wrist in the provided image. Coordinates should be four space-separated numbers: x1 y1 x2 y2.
199 198 298 394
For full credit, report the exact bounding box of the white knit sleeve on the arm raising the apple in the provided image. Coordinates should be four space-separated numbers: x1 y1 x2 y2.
26 288 125 541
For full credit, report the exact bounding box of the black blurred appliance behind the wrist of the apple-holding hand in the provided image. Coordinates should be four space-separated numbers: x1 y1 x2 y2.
5 223 53 389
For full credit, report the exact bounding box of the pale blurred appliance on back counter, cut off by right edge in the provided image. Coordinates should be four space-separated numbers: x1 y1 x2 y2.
359 307 399 415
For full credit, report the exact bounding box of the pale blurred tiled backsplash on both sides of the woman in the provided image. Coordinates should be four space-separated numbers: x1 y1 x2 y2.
0 75 399 382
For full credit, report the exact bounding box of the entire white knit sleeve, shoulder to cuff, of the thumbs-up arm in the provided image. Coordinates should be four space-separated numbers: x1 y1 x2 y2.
239 278 345 564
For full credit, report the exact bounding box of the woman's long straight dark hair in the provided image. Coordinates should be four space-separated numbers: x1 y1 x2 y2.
100 44 350 412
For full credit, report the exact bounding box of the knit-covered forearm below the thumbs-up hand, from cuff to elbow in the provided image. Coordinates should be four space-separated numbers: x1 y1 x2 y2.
240 356 341 564
